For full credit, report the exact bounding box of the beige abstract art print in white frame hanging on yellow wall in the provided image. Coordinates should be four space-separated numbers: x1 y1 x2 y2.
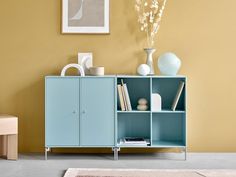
62 0 109 34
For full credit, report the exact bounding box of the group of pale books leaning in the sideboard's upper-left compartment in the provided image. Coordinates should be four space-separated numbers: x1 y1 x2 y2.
117 79 132 111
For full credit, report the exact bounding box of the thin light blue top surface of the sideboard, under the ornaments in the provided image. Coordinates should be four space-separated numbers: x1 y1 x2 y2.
46 75 186 78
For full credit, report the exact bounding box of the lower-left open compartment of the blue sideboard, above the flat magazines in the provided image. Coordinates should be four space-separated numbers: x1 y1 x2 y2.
117 113 151 142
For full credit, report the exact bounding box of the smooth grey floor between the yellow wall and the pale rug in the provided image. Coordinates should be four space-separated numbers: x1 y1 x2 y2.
0 153 236 177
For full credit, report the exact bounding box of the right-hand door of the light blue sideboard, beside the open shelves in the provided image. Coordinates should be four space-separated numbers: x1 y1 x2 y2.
80 77 115 147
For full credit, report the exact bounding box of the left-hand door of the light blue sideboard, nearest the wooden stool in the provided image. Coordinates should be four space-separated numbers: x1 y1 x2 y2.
45 77 80 147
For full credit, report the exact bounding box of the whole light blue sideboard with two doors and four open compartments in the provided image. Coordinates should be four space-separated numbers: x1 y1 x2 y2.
45 76 187 159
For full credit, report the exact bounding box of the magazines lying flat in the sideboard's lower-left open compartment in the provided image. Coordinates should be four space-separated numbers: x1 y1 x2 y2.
119 137 150 146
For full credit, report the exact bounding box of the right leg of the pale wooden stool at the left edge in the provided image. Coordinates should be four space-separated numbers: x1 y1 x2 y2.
7 135 18 160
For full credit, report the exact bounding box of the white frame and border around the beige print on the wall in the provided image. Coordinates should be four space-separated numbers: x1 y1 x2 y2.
62 0 110 34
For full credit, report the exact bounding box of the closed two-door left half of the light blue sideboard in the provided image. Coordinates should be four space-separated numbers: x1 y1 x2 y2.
45 77 116 148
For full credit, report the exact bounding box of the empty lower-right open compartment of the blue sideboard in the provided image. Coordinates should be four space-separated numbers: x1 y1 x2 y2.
152 113 186 147
